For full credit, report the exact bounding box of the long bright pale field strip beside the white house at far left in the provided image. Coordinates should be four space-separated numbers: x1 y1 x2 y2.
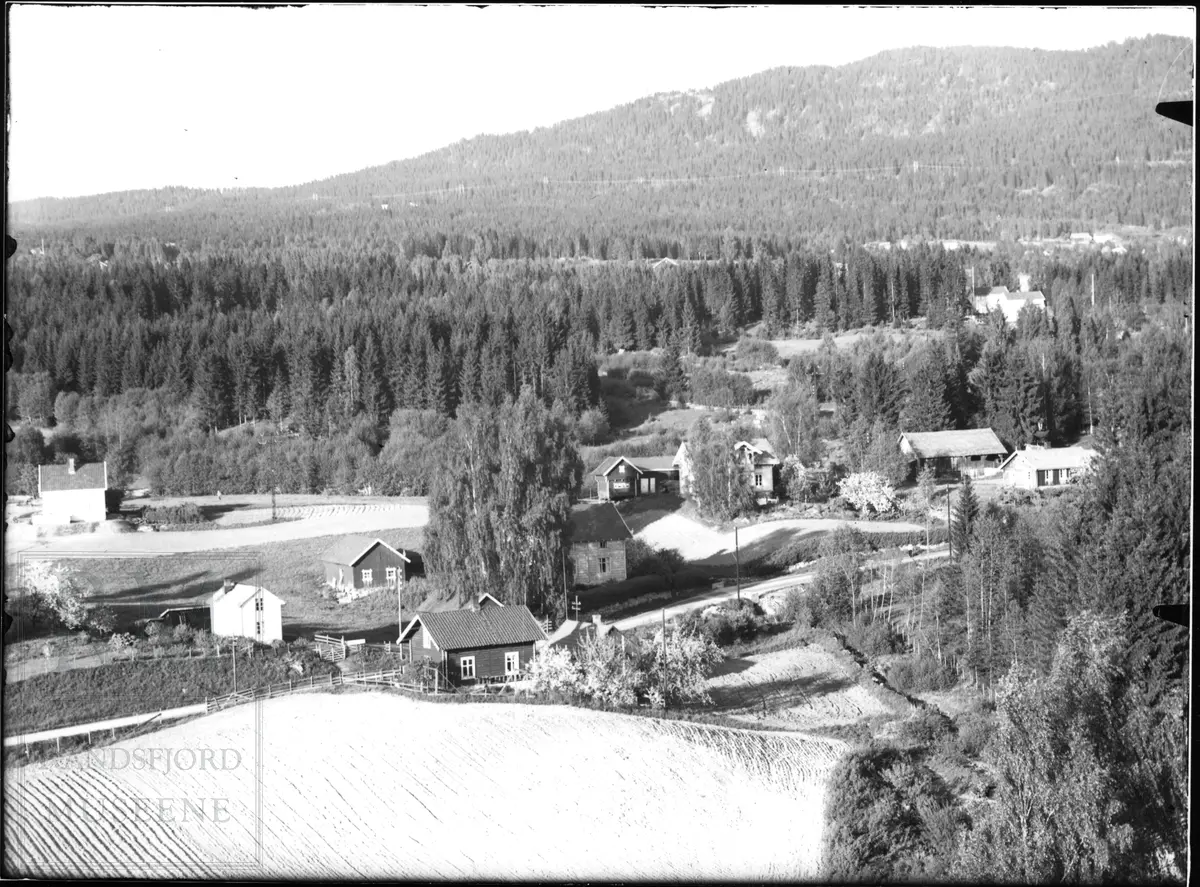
5 496 430 563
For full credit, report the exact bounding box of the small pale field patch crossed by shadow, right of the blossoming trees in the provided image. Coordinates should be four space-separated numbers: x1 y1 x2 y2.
708 645 895 730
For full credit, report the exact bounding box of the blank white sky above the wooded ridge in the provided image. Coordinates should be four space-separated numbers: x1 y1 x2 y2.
6 4 1195 200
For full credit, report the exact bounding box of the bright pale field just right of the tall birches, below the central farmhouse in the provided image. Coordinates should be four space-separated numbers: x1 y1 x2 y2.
637 514 924 565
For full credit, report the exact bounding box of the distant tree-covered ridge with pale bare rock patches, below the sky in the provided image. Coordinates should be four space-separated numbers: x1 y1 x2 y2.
14 37 1193 242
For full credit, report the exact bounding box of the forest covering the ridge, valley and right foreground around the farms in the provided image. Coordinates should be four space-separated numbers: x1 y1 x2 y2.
5 31 1194 882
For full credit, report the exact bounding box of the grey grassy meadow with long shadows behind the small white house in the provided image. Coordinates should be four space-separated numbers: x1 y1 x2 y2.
5 528 424 641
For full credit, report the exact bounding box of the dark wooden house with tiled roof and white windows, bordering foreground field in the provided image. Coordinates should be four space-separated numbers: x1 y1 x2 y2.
400 595 546 684
